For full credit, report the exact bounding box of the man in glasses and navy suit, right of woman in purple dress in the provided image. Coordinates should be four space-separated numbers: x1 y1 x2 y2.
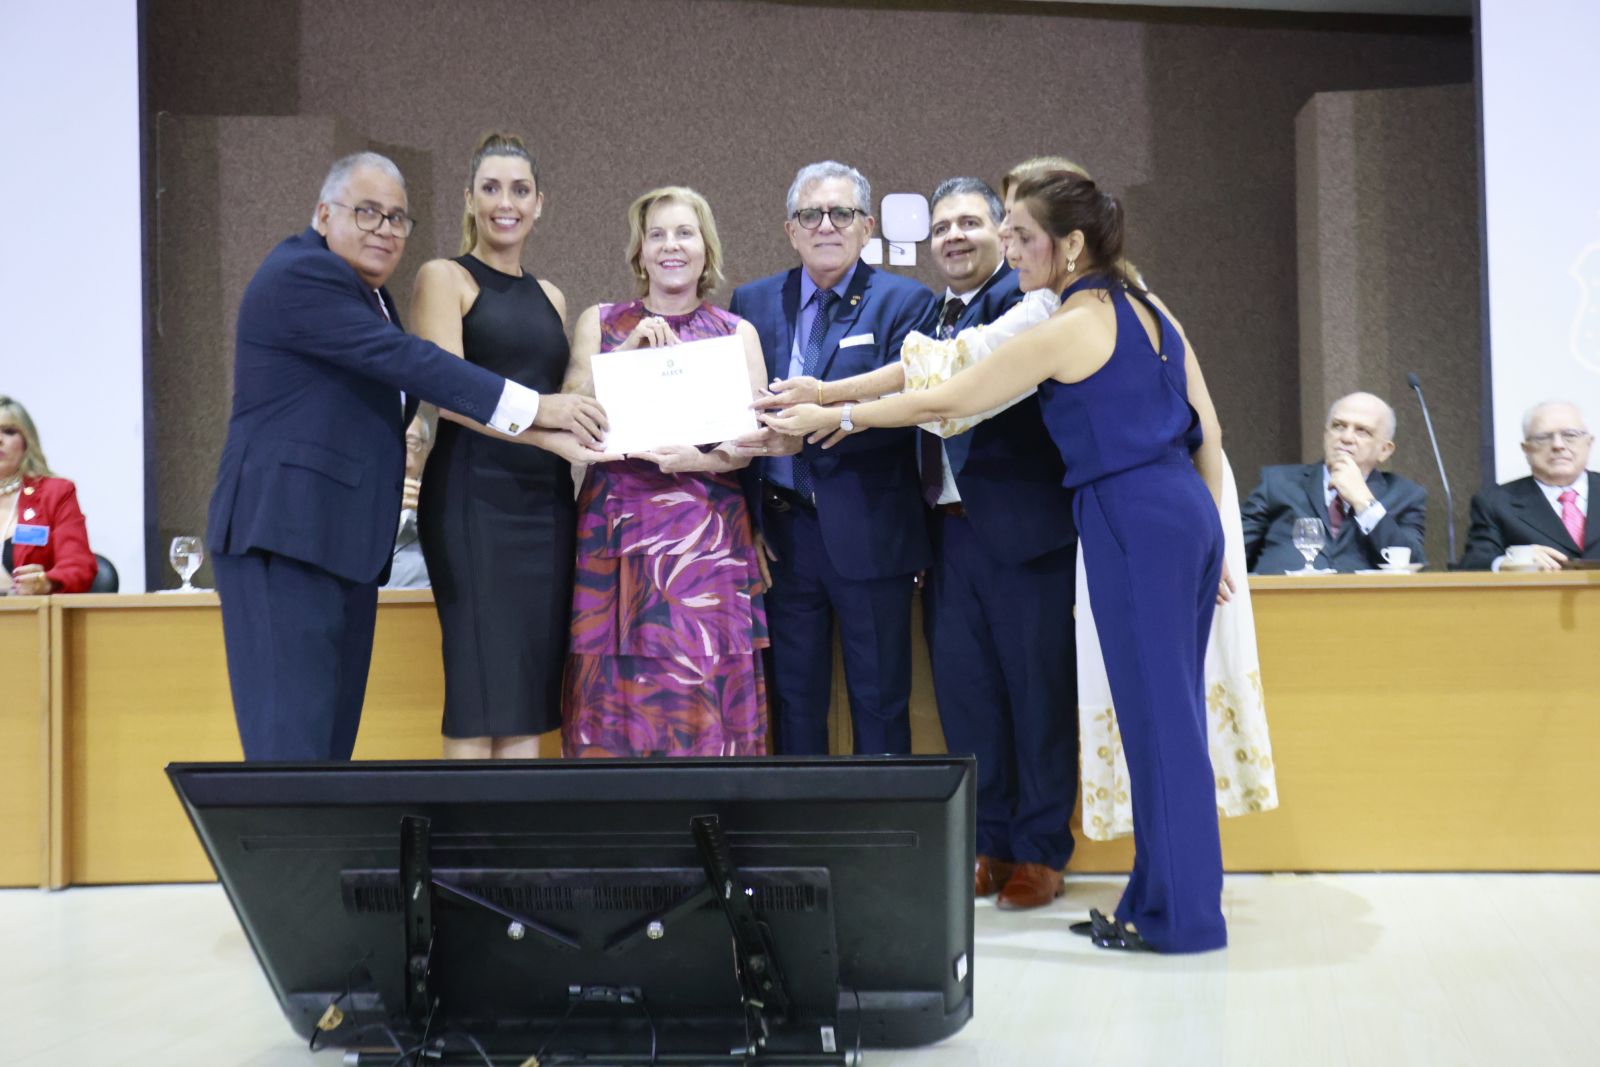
728 162 931 755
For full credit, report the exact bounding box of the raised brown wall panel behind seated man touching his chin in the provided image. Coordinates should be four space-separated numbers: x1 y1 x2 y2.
1296 85 1483 565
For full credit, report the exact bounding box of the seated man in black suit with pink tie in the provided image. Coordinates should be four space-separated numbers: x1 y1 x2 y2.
1461 400 1600 571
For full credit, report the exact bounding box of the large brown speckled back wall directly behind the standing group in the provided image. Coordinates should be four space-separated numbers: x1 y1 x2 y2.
147 0 1472 556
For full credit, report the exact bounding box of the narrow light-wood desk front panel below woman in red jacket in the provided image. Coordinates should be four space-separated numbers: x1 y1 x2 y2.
0 597 50 888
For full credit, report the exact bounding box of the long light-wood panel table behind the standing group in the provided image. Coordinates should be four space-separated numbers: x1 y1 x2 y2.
12 573 1600 886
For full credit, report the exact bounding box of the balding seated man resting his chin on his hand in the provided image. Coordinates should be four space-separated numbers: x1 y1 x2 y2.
1240 392 1427 574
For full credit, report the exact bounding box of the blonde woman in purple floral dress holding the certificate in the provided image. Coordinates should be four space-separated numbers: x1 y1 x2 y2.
562 187 768 757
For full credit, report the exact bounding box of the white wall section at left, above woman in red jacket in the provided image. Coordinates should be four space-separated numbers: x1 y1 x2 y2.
0 0 145 592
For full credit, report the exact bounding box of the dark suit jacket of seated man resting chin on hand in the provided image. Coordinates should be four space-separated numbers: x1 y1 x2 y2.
1240 462 1427 574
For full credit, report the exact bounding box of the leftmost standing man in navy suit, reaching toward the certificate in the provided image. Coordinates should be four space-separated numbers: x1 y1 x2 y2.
206 152 605 760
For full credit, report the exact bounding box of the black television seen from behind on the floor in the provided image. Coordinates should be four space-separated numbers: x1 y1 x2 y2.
168 757 974 1065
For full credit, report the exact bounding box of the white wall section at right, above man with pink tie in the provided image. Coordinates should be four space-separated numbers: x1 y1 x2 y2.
1462 0 1600 482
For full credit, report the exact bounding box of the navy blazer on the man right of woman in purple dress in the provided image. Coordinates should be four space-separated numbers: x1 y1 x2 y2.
728 262 933 581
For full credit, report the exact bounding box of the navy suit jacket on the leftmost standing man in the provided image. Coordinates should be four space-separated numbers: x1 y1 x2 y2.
206 229 506 582
